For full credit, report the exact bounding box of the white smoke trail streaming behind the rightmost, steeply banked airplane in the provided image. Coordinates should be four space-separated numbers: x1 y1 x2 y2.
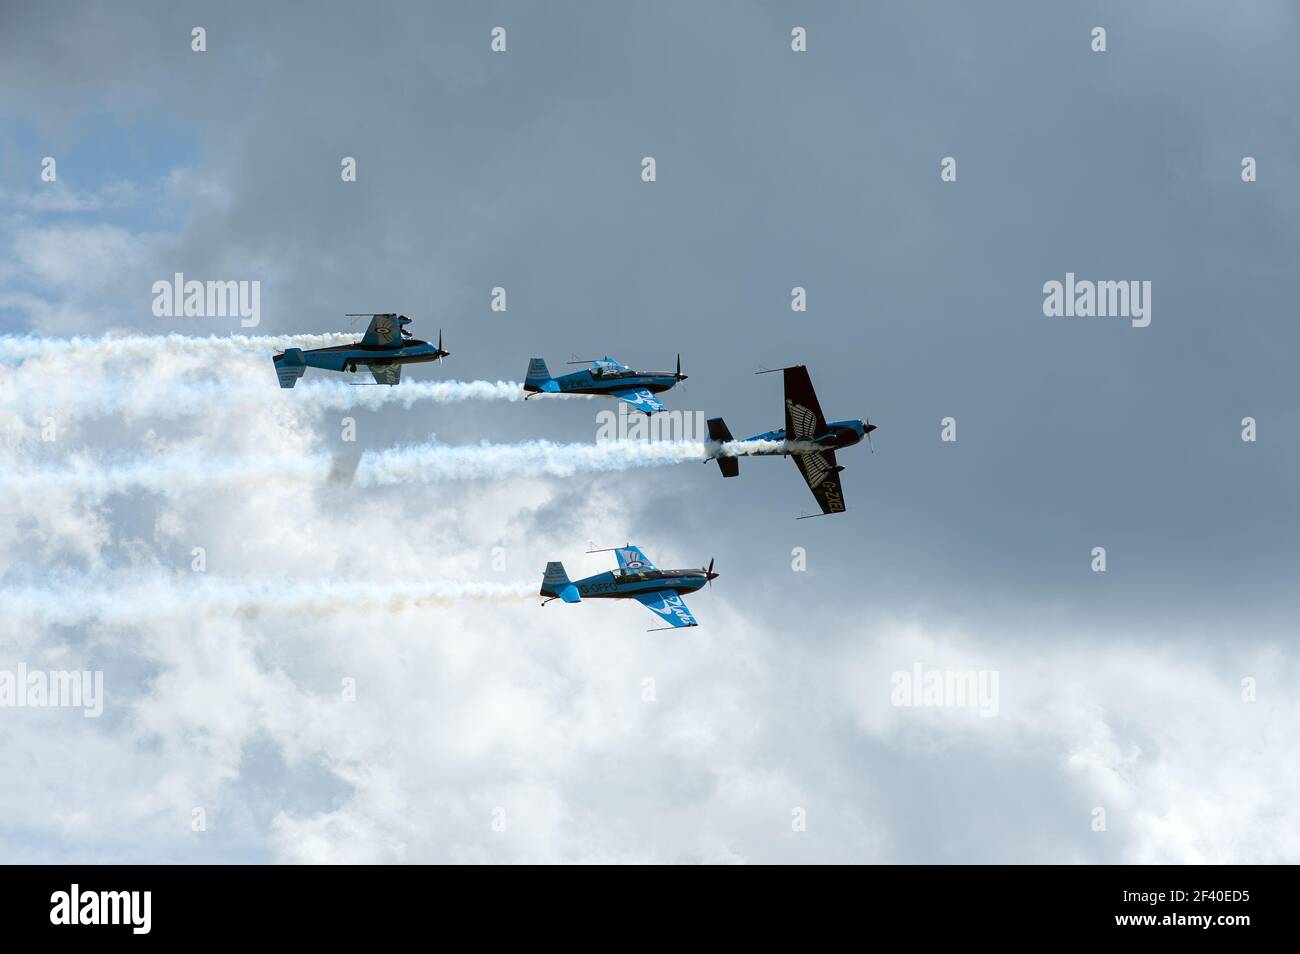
0 441 793 499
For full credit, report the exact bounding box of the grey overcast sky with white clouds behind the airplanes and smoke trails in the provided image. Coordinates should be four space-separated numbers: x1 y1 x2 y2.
0 3 1300 862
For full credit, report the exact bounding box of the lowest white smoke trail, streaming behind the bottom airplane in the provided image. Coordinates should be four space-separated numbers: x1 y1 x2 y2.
0 571 541 626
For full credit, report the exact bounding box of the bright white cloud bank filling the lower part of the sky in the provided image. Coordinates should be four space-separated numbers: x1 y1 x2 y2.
0 345 1300 862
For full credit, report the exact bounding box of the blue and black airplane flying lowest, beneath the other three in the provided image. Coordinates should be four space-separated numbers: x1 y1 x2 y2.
541 543 718 633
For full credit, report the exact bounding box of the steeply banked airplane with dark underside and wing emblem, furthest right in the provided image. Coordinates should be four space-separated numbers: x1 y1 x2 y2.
709 364 876 520
